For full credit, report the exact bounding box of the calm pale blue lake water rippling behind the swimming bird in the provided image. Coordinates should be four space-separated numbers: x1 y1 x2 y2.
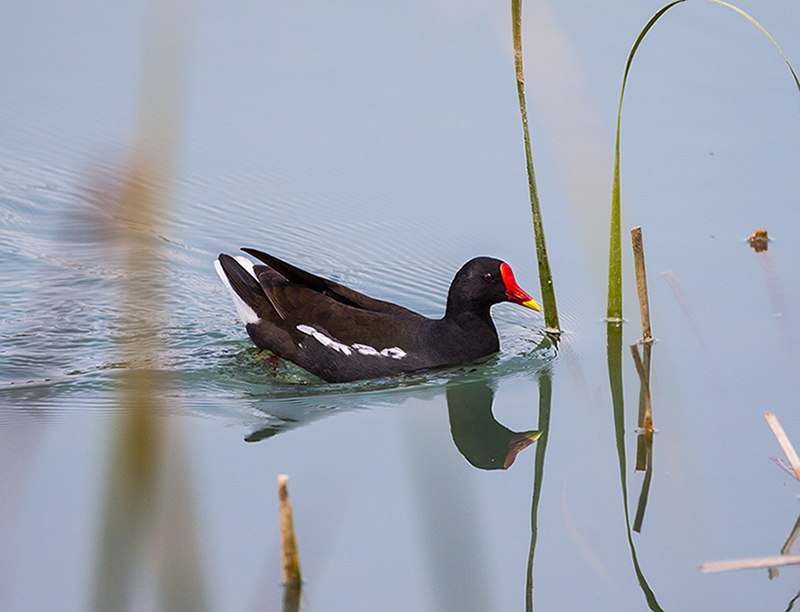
0 0 800 612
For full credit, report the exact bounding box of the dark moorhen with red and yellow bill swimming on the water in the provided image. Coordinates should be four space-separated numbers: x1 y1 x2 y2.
214 249 539 382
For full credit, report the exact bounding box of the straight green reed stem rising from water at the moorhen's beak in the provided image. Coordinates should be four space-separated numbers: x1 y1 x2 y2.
511 0 561 340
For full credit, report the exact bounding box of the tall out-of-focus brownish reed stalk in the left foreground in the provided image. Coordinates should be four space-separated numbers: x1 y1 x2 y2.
92 0 206 612
